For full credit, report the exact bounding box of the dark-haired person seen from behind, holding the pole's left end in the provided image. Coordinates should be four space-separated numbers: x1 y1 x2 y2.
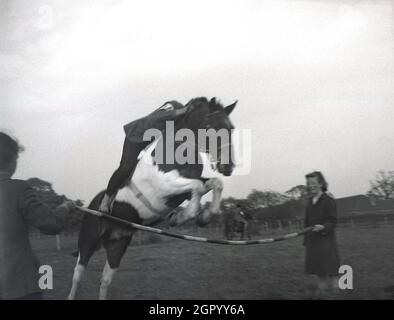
0 132 74 300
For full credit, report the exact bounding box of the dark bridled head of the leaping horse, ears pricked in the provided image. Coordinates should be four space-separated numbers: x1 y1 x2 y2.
181 98 237 176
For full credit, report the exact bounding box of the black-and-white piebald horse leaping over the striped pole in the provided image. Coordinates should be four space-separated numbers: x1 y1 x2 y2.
68 97 237 300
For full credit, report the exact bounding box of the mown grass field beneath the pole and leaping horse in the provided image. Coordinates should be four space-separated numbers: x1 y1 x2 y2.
32 225 394 300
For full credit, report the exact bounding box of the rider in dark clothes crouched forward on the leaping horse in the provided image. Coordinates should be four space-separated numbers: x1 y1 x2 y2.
99 101 189 213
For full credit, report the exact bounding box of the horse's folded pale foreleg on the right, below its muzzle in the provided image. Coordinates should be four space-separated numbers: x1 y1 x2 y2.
196 178 223 226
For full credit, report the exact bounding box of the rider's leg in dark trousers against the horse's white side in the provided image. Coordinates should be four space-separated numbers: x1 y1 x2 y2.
99 138 146 212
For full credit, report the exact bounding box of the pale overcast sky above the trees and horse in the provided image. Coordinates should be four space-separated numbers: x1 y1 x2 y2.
0 0 394 201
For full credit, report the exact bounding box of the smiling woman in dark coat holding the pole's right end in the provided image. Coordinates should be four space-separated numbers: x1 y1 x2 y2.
304 171 340 297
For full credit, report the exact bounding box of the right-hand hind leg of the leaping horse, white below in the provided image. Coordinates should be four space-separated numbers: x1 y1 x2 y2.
99 236 132 300
